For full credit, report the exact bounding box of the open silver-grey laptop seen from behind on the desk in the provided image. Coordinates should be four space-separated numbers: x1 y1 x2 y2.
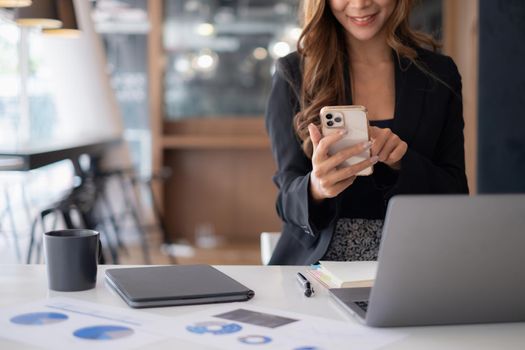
330 194 525 327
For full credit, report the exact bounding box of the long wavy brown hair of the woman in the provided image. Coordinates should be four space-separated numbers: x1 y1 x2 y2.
294 0 440 157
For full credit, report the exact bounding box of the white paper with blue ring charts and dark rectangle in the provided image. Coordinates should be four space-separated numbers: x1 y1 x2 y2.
171 304 407 350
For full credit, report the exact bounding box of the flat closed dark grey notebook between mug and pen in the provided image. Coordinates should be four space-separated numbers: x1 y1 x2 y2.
106 265 254 308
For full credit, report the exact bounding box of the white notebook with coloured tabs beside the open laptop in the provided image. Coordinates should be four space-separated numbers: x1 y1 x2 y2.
308 261 377 288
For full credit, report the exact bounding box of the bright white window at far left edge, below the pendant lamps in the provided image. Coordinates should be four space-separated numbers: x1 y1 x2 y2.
0 12 58 148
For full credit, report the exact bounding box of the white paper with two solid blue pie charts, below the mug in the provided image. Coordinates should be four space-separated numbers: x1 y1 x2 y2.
0 298 173 350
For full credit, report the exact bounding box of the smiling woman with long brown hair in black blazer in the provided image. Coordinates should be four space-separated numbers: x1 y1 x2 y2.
266 0 468 265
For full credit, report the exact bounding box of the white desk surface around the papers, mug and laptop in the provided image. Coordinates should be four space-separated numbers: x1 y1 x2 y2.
0 265 525 350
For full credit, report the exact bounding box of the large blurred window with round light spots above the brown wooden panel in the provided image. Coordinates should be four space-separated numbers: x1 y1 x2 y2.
164 0 300 120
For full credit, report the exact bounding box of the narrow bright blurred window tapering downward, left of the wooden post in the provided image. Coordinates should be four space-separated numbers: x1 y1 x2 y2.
92 0 151 175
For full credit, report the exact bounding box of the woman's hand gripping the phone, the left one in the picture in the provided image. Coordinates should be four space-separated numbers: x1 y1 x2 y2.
308 124 378 202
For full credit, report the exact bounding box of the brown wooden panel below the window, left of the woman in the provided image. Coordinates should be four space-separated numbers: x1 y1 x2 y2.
164 149 281 242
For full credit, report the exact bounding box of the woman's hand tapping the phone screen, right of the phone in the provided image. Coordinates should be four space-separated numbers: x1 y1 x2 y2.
369 126 408 170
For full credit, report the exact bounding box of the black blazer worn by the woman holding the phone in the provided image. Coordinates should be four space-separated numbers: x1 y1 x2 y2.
266 49 468 265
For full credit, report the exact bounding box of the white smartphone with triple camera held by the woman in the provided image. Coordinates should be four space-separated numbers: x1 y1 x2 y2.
321 106 373 176
